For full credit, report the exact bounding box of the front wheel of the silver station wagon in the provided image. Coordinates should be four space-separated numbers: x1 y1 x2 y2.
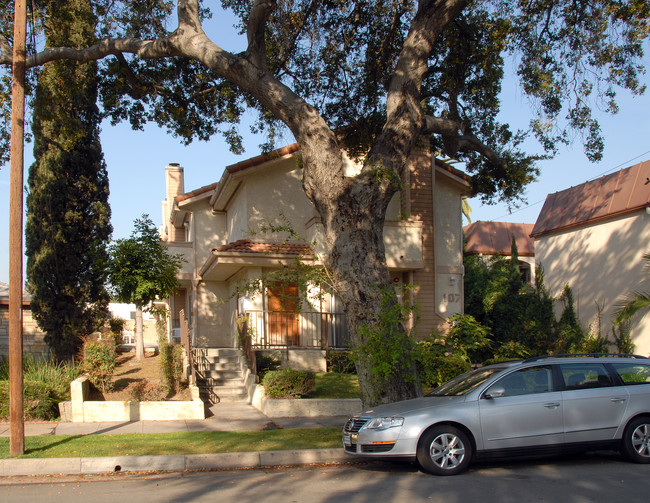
417 425 473 475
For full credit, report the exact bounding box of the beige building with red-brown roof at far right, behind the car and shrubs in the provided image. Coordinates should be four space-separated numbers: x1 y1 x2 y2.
532 161 650 355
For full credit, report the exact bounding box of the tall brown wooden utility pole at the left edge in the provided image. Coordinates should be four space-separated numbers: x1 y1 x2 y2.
9 0 27 456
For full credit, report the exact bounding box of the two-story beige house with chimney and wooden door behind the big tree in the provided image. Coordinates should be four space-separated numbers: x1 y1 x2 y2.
161 144 469 368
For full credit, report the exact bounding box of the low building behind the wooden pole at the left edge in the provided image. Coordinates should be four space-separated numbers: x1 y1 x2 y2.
0 283 50 358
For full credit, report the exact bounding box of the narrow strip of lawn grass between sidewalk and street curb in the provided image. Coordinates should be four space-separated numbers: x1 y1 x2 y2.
0 428 341 459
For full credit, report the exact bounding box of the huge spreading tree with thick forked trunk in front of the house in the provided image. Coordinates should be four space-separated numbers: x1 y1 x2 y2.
0 0 650 406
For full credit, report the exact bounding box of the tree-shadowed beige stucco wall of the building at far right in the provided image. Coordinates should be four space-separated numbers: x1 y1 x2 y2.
535 211 650 355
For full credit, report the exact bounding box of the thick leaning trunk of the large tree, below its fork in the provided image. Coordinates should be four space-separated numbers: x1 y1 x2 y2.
323 179 422 407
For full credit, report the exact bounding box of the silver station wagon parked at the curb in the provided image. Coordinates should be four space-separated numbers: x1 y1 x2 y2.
343 355 650 475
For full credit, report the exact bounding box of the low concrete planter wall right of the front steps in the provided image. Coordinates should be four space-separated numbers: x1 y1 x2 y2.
251 385 361 417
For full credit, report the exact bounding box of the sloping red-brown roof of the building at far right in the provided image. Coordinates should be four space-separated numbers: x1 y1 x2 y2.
532 161 650 238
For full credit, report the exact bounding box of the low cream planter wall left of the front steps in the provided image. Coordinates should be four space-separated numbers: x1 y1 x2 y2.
61 376 205 423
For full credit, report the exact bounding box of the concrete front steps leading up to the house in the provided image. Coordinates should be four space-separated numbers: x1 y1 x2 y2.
193 348 255 403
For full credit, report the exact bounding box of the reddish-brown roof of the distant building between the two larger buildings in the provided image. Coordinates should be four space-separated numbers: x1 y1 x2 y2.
463 220 535 257
